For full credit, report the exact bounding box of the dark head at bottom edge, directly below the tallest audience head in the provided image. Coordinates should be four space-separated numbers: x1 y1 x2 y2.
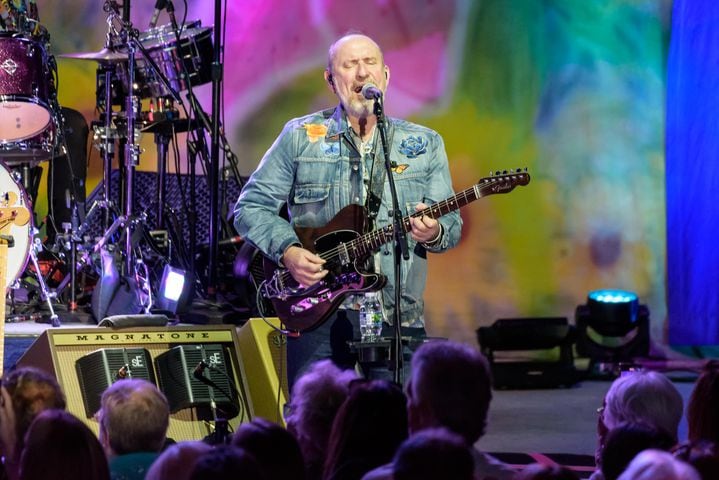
392 428 474 480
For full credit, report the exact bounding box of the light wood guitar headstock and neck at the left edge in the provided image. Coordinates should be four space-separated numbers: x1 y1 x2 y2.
0 192 30 376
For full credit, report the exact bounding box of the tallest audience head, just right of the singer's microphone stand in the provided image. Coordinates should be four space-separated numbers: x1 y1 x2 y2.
406 341 492 445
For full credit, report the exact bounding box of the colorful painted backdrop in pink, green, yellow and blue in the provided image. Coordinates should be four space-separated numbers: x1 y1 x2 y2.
38 0 671 343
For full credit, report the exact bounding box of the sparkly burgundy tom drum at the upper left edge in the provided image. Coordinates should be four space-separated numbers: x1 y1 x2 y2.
0 33 54 165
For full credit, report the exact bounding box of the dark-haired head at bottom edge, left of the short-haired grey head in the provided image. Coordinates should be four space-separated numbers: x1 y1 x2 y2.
20 410 110 480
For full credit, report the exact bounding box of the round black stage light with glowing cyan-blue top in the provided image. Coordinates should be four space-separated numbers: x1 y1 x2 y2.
575 289 649 364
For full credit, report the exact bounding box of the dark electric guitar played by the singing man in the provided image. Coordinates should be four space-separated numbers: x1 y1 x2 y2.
259 169 529 332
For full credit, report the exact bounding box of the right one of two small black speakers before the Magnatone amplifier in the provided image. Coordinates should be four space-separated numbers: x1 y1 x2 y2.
155 345 239 420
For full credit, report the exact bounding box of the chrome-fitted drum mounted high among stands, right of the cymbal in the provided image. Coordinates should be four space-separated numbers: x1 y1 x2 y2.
121 21 212 98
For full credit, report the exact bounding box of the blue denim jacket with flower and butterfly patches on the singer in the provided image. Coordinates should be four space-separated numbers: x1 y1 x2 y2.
235 106 462 327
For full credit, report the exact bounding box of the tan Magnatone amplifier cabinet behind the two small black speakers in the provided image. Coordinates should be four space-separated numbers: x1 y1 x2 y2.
17 325 253 441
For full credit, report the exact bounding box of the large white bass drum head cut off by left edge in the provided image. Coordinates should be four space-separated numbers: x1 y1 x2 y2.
0 162 33 287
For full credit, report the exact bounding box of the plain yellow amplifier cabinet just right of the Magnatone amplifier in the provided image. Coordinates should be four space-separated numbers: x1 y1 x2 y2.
237 318 290 424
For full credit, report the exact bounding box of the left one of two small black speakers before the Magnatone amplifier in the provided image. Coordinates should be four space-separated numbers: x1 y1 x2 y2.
75 348 155 418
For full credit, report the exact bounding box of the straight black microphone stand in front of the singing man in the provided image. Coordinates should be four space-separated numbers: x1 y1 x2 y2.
373 96 409 386
